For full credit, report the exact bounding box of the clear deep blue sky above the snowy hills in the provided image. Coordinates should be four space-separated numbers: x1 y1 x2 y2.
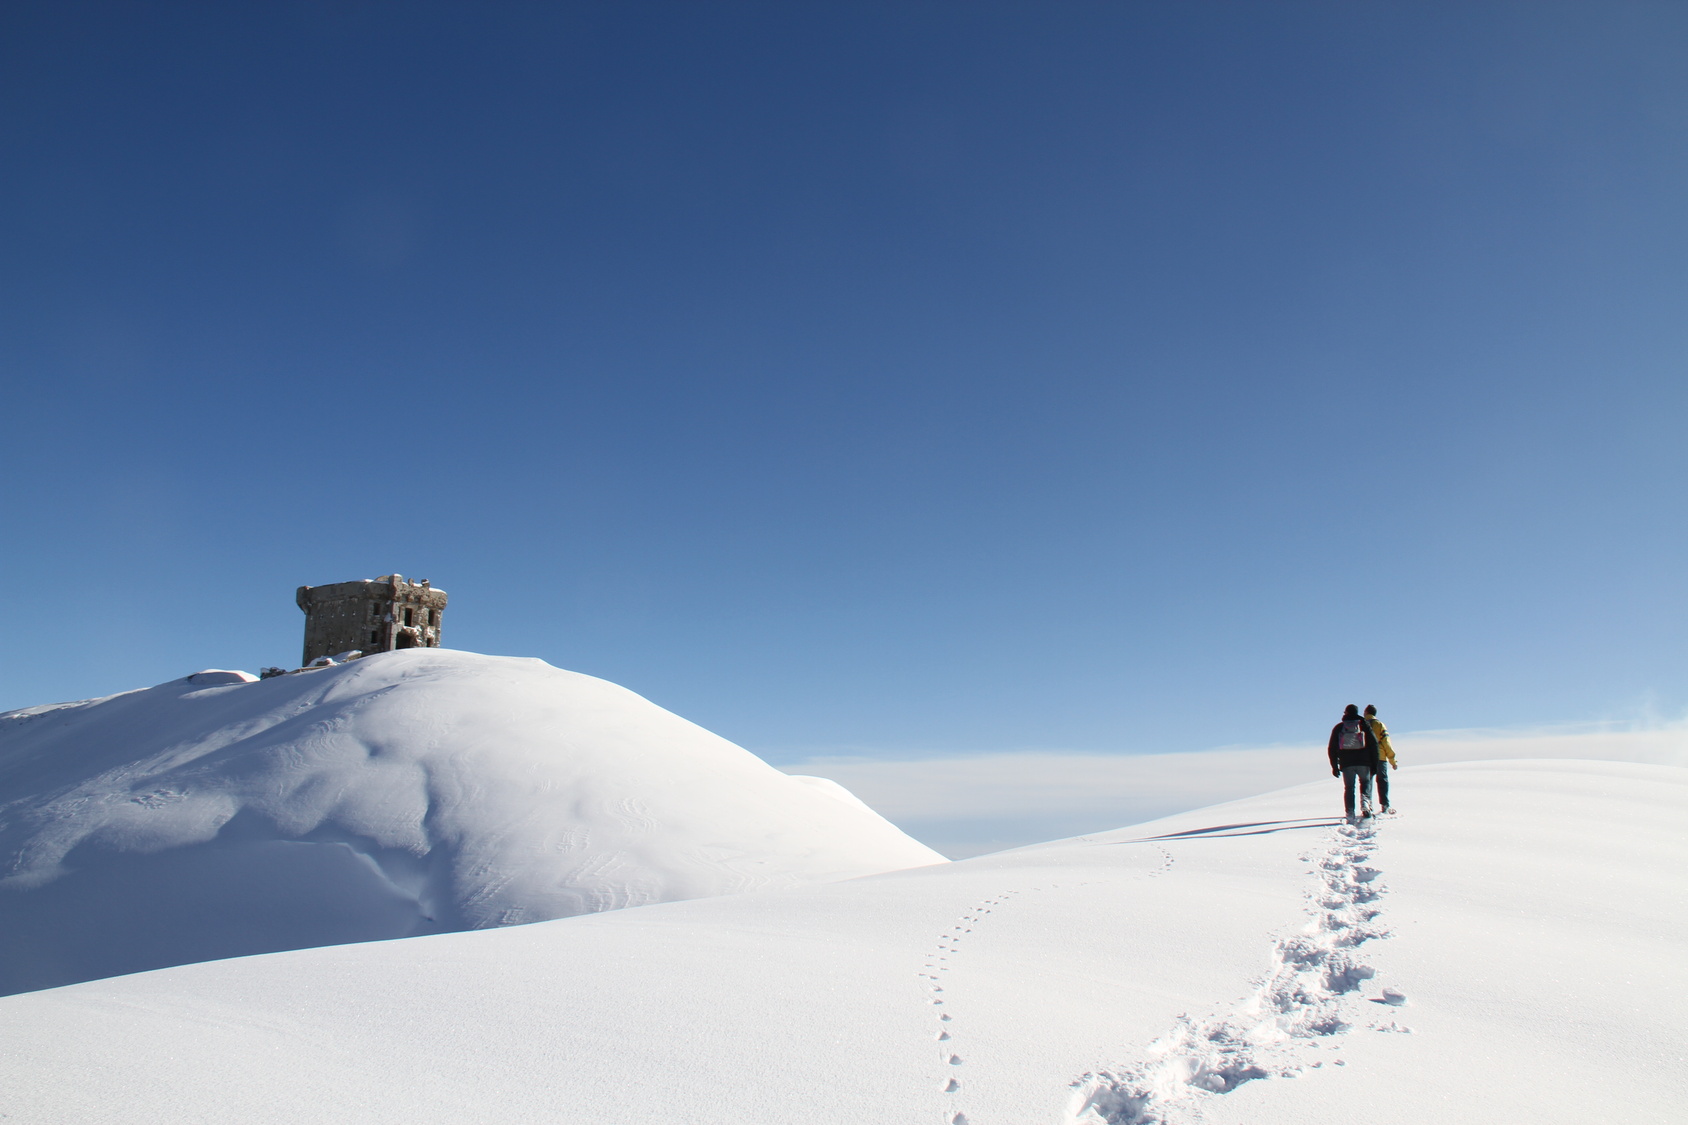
0 0 1688 760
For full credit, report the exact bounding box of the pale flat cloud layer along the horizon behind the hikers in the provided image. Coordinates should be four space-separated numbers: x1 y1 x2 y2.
782 723 1688 858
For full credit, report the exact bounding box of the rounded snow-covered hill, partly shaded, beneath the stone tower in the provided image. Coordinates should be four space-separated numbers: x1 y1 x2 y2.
0 649 944 992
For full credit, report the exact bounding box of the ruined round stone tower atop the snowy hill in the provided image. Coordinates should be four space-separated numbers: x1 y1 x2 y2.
294 574 446 664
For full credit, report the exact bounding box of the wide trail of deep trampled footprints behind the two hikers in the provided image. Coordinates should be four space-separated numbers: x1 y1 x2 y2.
1067 824 1411 1125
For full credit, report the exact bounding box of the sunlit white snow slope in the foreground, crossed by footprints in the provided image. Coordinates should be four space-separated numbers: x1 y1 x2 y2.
0 753 1688 1125
